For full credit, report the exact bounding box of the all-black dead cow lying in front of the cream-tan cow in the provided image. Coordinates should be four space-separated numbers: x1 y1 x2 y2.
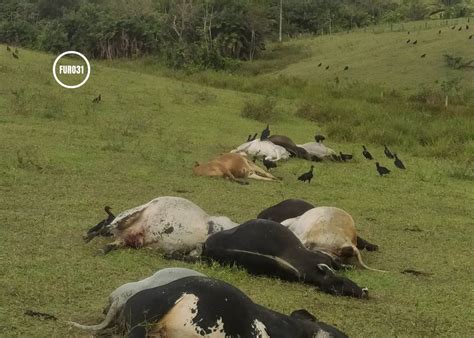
202 219 368 298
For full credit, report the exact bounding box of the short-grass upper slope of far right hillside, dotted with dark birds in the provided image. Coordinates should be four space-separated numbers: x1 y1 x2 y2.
278 20 474 94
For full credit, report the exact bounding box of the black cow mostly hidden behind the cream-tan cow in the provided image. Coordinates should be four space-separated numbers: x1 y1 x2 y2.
257 199 378 251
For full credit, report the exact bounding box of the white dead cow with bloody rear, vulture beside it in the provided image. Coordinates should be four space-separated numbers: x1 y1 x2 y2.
87 196 236 255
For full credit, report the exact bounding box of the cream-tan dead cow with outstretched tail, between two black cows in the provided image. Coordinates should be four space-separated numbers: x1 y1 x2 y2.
281 207 383 272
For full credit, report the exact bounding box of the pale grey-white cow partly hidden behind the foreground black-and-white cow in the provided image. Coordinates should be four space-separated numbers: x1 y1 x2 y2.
69 268 204 332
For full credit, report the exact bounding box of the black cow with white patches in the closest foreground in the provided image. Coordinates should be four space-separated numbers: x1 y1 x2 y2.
118 277 347 338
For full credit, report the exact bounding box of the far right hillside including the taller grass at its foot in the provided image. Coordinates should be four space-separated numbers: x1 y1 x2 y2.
104 18 474 161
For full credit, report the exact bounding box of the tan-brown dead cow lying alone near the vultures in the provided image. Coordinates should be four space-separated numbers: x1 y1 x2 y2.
193 153 277 184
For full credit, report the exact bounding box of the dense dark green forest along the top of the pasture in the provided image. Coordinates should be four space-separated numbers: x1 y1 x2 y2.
0 0 472 69
